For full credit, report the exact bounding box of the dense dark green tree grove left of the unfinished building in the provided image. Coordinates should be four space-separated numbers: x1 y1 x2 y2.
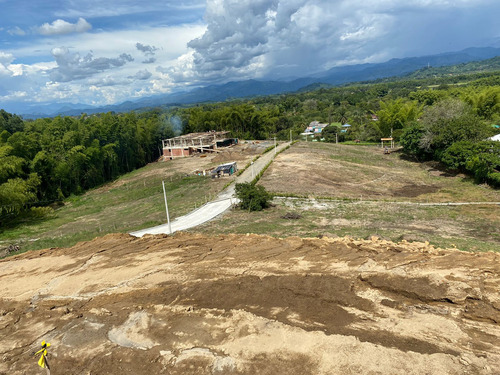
0 110 173 224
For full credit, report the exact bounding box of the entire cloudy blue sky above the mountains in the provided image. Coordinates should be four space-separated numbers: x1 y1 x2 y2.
0 0 500 108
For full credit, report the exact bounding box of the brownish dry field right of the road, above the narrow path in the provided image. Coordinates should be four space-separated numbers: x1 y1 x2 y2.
259 142 500 202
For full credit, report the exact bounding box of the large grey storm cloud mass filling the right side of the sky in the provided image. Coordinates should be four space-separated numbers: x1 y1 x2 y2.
172 0 500 82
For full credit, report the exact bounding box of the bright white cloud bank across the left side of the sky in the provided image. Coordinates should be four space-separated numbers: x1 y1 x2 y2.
0 24 206 105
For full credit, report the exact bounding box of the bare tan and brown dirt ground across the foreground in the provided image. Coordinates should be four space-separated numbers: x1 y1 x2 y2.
0 233 500 375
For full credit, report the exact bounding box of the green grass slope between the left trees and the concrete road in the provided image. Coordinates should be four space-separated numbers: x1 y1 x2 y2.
0 160 227 251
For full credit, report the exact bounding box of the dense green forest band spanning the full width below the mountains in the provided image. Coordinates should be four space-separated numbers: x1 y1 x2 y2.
0 68 500 224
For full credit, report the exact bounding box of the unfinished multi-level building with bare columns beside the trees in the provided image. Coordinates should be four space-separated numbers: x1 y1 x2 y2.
162 131 238 160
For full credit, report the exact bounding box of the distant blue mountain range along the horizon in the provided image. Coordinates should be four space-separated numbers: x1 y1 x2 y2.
7 47 500 118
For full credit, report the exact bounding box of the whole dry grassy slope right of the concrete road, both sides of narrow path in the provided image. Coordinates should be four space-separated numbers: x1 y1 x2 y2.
195 142 500 251
